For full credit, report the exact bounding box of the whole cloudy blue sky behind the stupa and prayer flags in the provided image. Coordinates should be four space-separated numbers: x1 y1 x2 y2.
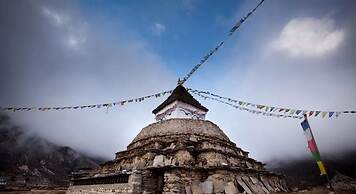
0 0 356 161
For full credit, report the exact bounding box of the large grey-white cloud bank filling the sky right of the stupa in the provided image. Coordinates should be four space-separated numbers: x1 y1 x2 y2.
206 1 356 161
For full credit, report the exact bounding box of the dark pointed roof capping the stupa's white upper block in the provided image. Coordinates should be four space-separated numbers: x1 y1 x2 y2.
152 85 208 114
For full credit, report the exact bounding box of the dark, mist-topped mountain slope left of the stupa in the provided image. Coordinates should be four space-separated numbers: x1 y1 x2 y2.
0 115 98 186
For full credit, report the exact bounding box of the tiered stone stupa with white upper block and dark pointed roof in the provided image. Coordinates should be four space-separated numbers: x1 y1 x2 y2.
67 85 287 194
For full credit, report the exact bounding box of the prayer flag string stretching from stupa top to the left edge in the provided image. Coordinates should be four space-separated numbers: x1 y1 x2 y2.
0 90 173 112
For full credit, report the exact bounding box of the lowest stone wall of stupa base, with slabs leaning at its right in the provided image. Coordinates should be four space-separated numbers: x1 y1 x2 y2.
163 170 287 194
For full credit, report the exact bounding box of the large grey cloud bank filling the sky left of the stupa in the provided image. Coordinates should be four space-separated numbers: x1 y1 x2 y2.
0 0 175 158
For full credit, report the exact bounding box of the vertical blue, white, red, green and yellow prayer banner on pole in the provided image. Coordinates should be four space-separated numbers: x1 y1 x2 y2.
301 117 327 175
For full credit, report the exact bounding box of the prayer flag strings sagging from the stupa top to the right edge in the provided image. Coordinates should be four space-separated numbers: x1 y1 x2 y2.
188 89 356 118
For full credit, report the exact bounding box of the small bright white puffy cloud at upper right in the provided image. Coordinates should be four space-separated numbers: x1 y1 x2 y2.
272 17 345 57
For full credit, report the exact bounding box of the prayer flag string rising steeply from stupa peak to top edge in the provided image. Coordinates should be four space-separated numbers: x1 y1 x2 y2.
178 0 264 85
